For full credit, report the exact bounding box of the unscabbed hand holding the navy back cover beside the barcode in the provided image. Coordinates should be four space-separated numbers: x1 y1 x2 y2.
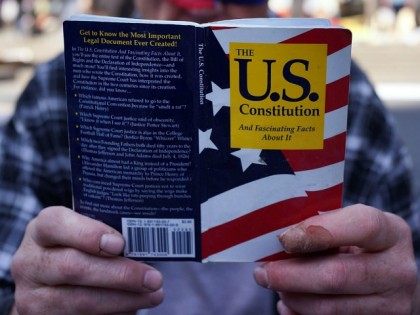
12 207 163 315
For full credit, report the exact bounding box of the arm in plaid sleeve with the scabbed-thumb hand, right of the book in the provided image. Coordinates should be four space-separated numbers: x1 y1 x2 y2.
255 64 420 314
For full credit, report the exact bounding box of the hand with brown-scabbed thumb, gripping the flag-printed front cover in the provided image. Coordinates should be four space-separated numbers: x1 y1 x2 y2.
254 205 416 315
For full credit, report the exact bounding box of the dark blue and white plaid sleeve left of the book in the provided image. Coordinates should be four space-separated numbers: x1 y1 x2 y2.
0 58 71 314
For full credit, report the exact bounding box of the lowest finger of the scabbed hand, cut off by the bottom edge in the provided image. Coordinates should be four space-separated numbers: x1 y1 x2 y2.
281 293 410 315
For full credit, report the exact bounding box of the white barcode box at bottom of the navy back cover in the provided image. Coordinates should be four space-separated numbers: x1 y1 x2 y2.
122 218 195 257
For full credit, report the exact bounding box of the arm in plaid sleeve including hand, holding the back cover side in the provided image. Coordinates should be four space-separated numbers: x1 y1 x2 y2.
0 56 163 314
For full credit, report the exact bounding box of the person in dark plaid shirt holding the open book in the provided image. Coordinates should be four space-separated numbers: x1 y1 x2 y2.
0 0 420 315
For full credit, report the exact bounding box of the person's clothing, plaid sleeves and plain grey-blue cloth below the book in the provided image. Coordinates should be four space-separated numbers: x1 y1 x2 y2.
0 55 420 314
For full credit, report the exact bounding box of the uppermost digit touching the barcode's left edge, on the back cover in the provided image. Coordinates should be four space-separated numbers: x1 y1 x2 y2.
28 207 124 256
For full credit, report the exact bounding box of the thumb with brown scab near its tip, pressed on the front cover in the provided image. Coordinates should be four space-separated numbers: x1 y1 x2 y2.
280 205 402 253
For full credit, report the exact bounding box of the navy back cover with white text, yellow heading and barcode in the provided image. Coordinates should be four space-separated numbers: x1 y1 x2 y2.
64 17 201 260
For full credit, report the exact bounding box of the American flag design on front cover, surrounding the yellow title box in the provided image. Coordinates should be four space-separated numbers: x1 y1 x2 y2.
198 19 351 262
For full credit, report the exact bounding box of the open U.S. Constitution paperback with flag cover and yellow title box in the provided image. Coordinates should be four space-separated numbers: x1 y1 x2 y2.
64 15 351 261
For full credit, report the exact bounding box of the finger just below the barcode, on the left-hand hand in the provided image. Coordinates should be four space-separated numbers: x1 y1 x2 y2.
32 248 163 293
